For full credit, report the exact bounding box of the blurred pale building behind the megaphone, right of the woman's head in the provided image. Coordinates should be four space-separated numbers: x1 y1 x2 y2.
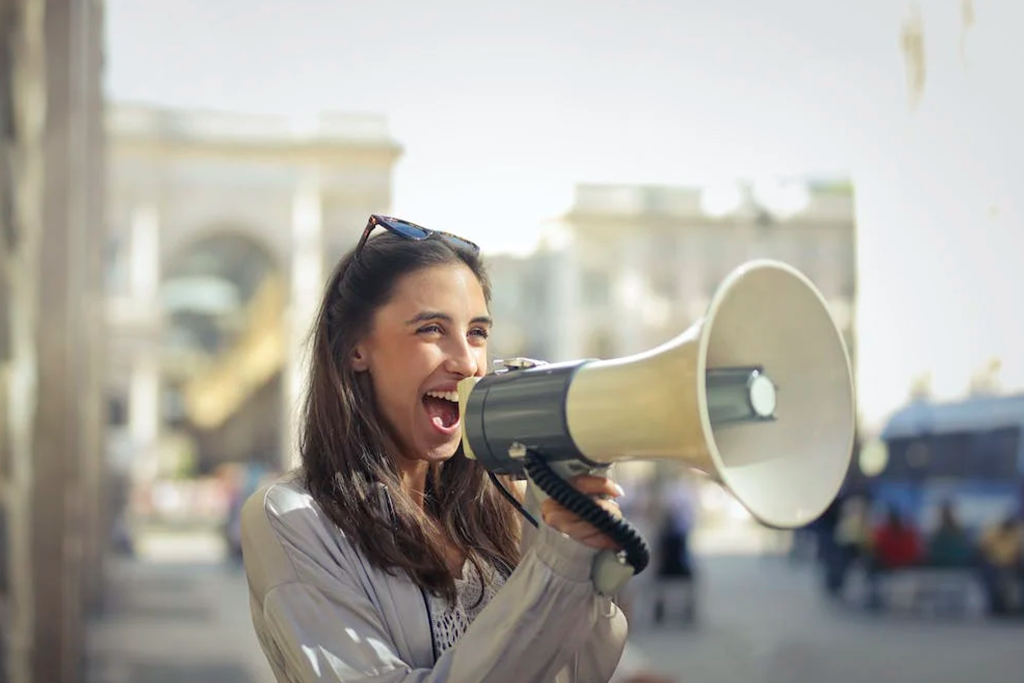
488 181 856 366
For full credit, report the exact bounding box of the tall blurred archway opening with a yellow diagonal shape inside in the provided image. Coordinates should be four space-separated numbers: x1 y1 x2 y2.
160 229 286 474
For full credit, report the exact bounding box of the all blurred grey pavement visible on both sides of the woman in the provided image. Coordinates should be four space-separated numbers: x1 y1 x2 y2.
81 531 1024 683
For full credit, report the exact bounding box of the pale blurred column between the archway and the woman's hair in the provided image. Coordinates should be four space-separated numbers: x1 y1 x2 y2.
281 168 324 470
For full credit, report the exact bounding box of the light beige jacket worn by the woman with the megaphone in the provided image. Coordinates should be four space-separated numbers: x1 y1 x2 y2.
242 474 627 683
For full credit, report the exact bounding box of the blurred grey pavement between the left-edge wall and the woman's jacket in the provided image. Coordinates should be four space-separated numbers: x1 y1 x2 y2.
87 531 273 683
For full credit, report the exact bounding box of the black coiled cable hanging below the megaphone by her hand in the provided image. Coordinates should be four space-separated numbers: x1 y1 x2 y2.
523 451 650 574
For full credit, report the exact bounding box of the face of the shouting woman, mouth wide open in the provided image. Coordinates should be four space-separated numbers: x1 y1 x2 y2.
352 263 490 471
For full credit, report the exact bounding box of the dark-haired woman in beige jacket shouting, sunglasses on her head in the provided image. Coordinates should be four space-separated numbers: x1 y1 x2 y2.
242 216 626 683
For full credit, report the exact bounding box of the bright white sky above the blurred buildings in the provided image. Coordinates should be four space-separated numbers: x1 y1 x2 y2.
106 0 1024 432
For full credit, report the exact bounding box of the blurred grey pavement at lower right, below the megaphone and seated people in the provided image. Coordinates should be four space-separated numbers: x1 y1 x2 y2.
635 557 1024 683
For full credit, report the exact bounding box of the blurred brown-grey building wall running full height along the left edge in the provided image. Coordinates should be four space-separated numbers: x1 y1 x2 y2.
0 0 105 683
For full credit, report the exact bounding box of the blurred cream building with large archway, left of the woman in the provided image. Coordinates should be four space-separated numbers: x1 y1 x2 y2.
105 103 400 489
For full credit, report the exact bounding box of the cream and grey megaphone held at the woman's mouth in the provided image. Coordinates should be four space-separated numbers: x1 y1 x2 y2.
459 260 855 528
